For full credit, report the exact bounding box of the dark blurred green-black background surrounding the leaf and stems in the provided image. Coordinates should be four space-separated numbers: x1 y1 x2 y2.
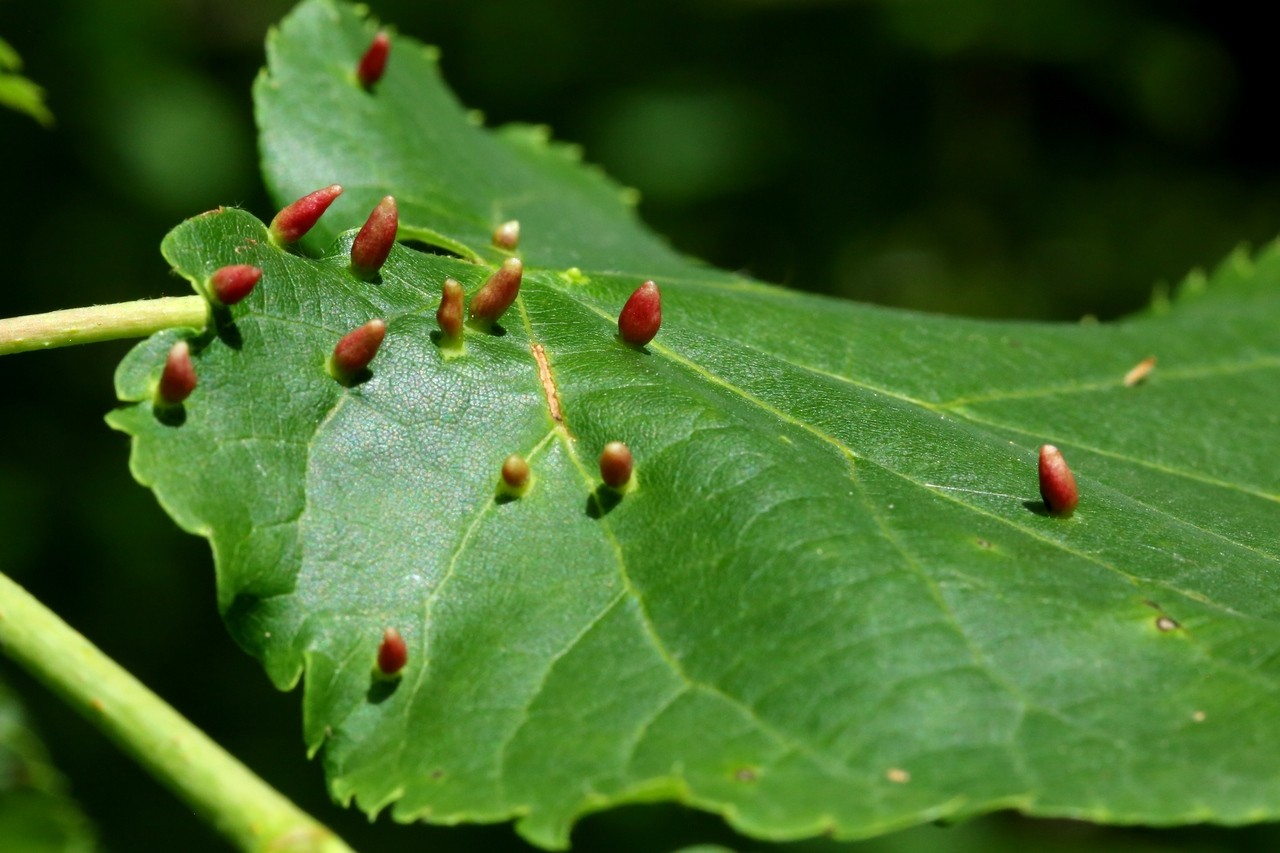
0 0 1280 852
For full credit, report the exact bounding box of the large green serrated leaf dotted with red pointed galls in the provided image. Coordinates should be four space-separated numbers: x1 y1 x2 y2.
110 0 1280 847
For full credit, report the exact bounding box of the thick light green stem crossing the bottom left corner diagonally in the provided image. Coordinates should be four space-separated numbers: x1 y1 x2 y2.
0 574 351 853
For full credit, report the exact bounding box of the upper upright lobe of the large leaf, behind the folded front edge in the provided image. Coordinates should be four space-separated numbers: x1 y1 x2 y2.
253 4 700 277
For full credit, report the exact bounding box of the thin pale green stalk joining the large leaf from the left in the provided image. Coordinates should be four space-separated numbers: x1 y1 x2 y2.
0 296 209 355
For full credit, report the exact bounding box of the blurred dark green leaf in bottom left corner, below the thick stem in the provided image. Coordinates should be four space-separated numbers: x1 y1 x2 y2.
0 676 96 853
